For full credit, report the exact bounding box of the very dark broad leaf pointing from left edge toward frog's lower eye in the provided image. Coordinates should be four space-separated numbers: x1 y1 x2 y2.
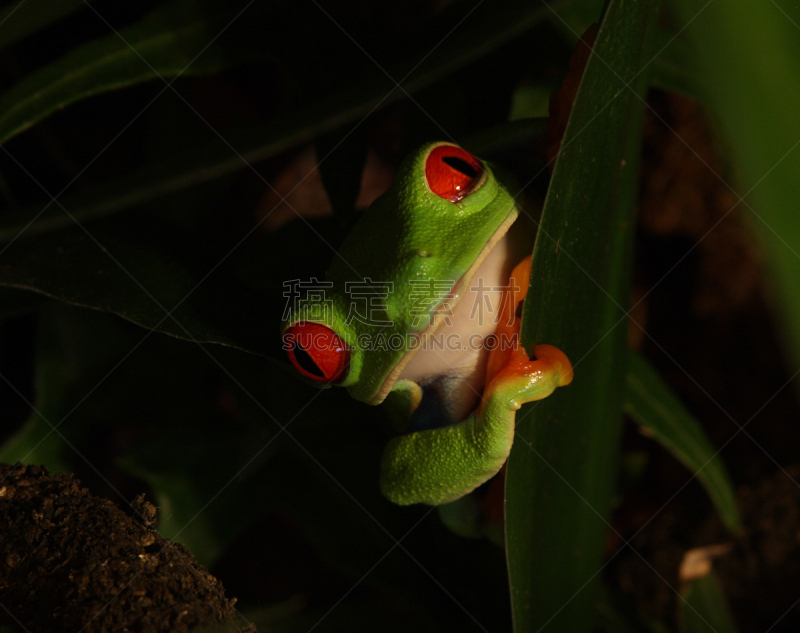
0 218 282 353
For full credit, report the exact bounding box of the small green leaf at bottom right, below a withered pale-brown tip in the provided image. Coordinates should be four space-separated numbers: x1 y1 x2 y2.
679 570 737 633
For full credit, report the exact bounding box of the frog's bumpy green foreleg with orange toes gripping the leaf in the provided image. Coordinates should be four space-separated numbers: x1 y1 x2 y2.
381 345 572 505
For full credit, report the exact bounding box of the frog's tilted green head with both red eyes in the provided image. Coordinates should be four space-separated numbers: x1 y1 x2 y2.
283 143 518 404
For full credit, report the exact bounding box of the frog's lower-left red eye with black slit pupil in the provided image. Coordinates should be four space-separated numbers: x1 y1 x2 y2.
283 321 350 382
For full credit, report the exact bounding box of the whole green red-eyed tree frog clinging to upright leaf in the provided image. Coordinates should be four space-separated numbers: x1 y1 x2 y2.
282 141 573 506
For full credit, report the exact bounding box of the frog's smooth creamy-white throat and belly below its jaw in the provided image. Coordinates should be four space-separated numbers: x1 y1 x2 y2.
400 221 531 420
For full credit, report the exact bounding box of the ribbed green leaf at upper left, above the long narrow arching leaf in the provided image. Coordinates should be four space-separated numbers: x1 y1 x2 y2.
0 0 247 143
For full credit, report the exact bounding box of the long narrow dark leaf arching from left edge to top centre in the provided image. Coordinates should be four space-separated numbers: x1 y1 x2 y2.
0 1 568 241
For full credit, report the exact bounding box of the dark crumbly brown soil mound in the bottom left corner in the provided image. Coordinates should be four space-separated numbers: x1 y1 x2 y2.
0 464 250 633
